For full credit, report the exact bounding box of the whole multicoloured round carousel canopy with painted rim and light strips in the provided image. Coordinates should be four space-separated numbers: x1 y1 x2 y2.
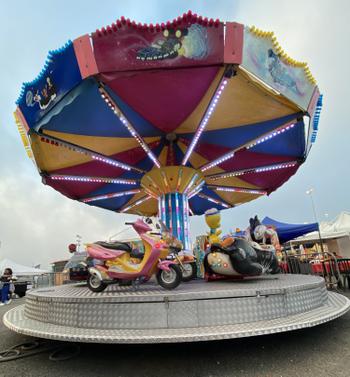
15 12 322 215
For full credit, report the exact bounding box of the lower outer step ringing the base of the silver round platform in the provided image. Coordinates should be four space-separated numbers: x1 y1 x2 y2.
3 292 350 344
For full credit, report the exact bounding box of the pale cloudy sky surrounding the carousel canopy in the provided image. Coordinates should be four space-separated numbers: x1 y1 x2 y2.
0 0 350 266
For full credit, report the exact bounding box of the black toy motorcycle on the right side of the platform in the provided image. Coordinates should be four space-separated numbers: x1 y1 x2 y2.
204 237 279 280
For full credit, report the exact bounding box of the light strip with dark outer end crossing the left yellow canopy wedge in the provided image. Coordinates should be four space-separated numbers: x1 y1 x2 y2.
37 131 145 173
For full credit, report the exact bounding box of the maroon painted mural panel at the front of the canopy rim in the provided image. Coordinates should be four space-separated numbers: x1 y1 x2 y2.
92 20 224 73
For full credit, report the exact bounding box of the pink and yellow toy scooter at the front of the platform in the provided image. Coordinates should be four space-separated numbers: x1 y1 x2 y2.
87 219 182 292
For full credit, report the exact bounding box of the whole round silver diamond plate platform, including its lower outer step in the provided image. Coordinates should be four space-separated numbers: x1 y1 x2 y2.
3 274 350 343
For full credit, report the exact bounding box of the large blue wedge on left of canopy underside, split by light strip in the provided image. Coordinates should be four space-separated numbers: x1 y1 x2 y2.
39 78 162 137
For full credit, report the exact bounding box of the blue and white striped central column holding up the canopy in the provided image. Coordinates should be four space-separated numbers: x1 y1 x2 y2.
158 192 191 250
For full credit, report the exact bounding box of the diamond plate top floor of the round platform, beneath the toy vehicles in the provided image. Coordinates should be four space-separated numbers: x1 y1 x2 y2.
27 274 324 303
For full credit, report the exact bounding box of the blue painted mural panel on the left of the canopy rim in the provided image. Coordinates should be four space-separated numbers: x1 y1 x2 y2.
16 41 82 128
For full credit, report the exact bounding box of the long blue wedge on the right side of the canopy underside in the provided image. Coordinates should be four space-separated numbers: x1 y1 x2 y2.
179 113 300 149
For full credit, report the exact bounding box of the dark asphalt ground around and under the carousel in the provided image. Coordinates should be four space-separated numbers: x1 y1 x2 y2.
0 291 350 377
